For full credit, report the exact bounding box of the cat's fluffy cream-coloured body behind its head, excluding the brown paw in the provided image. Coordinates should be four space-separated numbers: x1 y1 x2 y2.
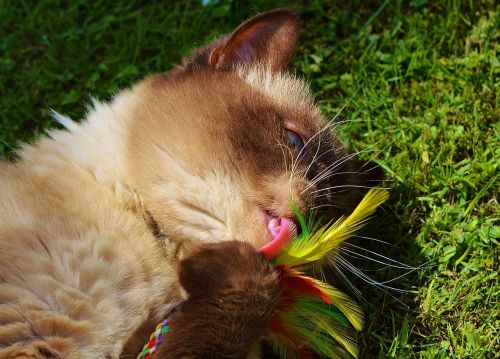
0 91 186 358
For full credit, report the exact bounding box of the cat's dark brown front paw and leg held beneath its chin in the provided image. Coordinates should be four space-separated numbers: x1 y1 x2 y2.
153 241 279 359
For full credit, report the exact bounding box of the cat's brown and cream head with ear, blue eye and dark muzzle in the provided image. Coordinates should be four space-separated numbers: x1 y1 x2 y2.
123 9 381 256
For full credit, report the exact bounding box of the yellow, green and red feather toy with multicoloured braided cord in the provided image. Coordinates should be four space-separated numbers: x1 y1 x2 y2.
138 188 389 359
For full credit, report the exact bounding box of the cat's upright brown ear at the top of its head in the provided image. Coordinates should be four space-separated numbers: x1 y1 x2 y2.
208 9 299 71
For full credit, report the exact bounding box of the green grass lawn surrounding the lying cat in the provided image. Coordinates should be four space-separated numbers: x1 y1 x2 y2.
0 0 500 358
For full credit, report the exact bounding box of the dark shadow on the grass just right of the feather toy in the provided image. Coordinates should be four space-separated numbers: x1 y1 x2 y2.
354 185 432 358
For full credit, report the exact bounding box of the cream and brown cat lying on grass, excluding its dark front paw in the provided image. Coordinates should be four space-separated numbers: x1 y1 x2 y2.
0 9 381 359
